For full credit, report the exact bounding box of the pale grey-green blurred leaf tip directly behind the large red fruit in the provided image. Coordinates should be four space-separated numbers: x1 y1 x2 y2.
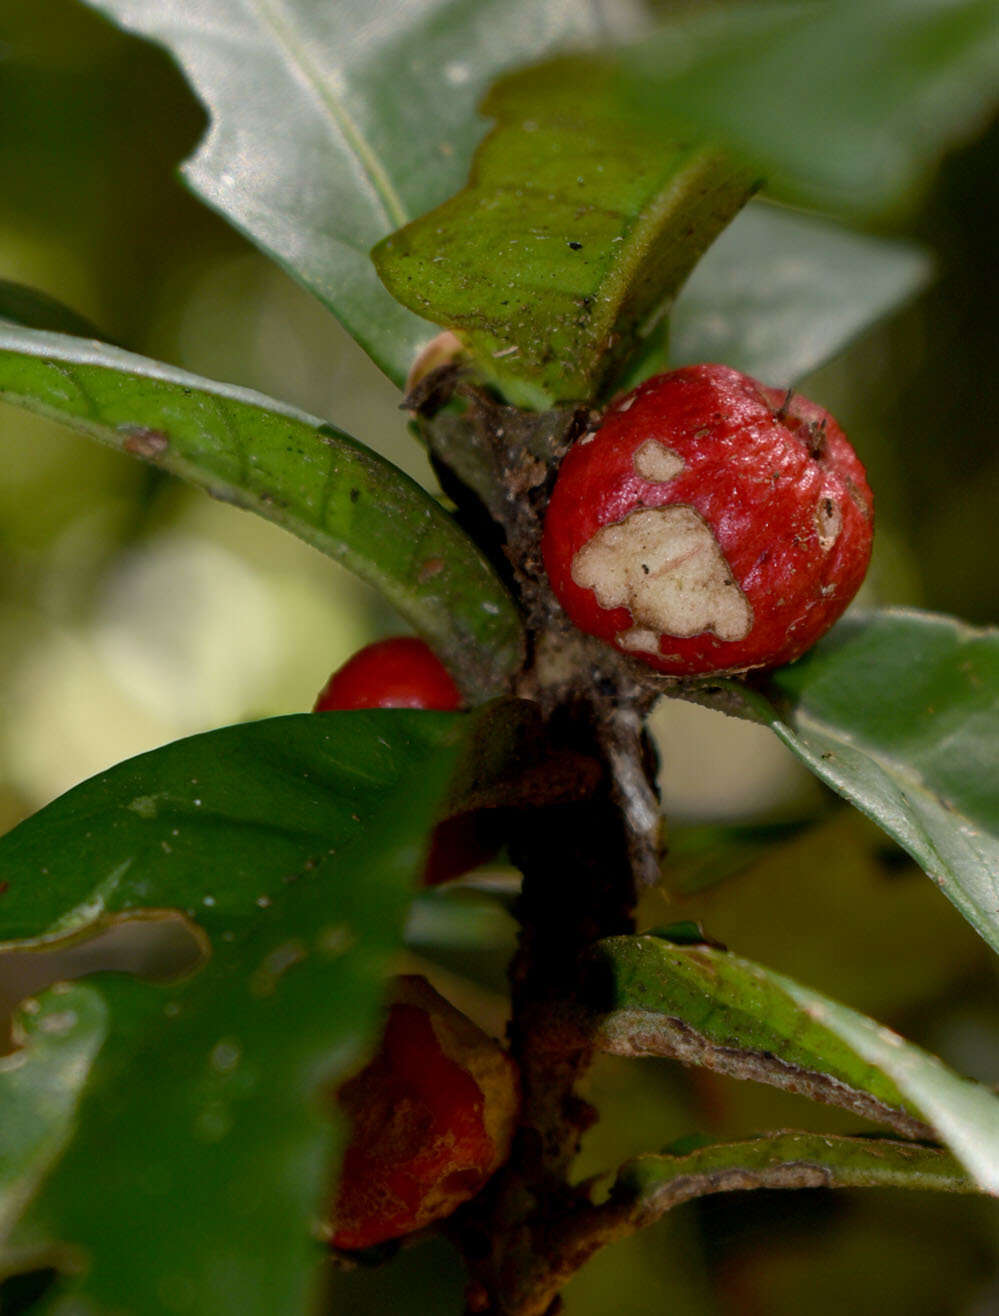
668 203 932 386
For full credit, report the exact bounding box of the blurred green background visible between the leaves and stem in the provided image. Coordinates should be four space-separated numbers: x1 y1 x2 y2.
0 0 999 1316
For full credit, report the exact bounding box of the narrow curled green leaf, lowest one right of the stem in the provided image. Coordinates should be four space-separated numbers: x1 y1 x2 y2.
615 1132 974 1228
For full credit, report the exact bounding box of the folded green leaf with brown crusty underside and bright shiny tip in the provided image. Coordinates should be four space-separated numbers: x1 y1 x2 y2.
591 936 999 1195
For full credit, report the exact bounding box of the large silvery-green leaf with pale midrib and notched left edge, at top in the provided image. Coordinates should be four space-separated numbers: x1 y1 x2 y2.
78 0 607 386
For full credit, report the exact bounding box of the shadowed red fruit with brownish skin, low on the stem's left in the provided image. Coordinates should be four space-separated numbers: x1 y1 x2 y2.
330 978 519 1249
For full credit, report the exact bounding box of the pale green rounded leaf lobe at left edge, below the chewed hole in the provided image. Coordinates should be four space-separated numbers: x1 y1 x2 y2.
0 984 108 1252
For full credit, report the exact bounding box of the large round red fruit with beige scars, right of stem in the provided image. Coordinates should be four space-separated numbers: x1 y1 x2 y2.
542 365 873 676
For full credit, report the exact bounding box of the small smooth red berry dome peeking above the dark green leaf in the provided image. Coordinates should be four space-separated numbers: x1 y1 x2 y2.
313 636 462 713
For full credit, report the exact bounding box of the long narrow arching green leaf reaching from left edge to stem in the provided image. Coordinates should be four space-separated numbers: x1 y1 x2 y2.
0 326 523 700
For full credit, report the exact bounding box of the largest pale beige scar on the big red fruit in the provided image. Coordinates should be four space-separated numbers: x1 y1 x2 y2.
573 505 753 653
